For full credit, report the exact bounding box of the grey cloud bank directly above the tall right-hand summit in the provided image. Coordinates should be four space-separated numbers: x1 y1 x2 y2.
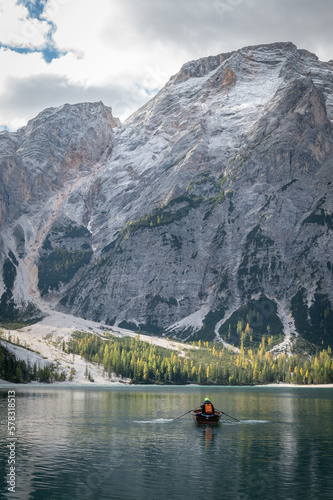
100 0 333 58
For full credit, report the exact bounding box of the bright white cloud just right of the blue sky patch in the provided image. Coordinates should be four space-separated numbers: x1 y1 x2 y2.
46 0 184 88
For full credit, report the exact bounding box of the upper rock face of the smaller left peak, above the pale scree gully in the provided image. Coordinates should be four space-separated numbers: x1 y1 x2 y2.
0 103 118 225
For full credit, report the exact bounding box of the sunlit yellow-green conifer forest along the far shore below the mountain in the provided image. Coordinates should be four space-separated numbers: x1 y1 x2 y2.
63 332 333 385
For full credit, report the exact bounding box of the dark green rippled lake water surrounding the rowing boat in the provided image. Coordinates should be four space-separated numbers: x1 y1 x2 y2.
0 386 333 500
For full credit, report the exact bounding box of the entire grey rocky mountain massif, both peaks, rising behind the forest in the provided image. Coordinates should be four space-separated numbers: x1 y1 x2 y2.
0 43 333 346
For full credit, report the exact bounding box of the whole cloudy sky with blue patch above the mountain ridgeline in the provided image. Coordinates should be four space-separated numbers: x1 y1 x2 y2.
0 0 333 131
